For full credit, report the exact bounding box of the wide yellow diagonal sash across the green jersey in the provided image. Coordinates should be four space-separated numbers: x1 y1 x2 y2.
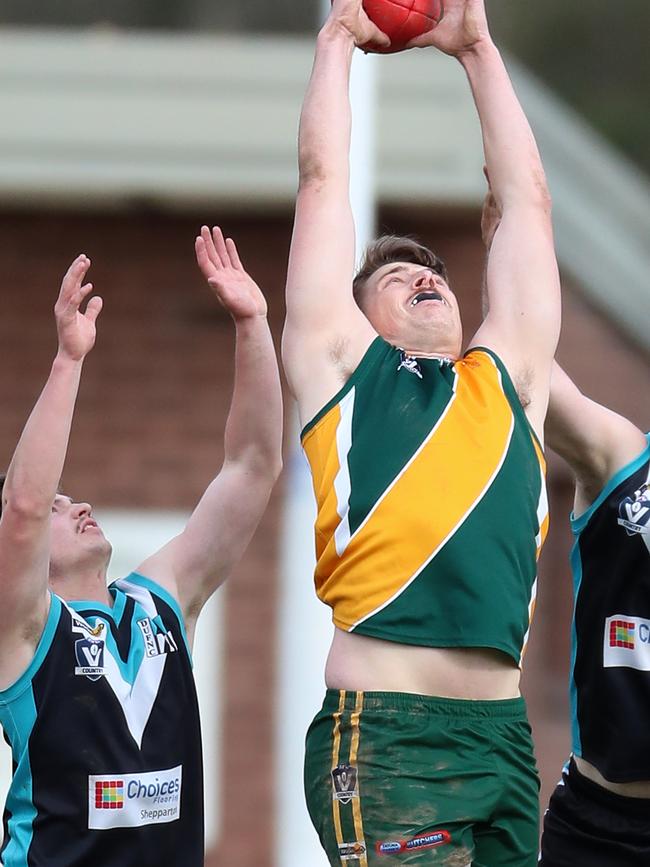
316 353 513 629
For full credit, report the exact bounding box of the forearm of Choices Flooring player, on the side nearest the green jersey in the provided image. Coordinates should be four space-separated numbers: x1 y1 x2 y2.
224 316 282 478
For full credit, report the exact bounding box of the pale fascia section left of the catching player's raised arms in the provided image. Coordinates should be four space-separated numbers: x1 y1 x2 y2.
0 30 309 204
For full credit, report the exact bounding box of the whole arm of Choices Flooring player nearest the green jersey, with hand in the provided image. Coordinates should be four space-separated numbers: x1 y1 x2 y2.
138 226 282 641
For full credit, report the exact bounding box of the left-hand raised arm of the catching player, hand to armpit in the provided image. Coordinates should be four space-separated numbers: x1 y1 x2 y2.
282 0 388 421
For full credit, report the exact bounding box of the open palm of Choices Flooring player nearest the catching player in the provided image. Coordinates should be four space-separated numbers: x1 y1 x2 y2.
194 226 267 320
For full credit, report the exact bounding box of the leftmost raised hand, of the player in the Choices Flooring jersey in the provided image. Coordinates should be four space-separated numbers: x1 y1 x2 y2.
54 253 103 361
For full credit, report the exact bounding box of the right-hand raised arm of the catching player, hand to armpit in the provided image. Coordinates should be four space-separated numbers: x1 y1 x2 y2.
415 0 560 432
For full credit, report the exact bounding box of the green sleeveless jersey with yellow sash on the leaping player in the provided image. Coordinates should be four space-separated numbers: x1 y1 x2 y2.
302 337 548 664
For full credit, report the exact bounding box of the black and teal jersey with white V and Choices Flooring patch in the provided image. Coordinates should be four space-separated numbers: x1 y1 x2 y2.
0 573 203 867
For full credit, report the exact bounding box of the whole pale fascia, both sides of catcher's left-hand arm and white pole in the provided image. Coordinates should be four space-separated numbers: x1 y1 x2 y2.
0 30 481 206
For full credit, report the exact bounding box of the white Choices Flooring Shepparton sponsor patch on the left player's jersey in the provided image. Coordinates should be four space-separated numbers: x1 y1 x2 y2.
88 765 183 831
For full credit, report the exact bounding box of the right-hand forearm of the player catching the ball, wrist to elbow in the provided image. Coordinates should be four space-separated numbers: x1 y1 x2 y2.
459 39 548 210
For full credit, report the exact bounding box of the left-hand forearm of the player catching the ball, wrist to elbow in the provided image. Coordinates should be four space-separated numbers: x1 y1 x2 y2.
298 21 354 185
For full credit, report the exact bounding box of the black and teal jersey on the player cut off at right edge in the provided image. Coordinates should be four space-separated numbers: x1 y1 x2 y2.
570 435 650 783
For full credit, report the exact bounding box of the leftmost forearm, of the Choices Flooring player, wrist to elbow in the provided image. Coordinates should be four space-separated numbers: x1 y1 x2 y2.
3 354 83 517
